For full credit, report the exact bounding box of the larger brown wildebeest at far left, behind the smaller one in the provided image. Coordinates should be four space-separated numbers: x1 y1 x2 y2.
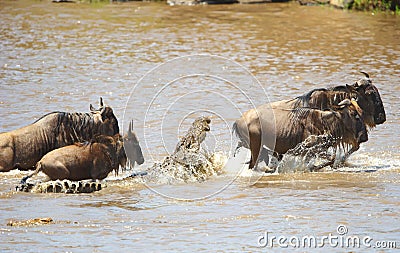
0 98 119 172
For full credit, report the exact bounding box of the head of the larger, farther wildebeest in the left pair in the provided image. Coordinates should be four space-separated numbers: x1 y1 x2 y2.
90 97 119 136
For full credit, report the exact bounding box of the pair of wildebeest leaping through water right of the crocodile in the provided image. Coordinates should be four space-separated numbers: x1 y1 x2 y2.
233 72 386 170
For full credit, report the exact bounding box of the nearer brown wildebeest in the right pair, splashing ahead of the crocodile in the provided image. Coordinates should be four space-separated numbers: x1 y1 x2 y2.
233 99 368 169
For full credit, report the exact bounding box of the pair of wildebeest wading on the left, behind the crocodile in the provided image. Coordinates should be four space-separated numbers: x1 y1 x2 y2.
0 98 144 181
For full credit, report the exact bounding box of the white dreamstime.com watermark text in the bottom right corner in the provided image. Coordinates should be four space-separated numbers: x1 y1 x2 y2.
257 225 400 249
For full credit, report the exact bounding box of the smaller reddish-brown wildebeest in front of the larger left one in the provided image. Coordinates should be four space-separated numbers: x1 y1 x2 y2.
21 121 144 184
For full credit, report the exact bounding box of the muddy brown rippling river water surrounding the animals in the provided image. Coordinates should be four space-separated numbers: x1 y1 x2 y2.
0 0 400 252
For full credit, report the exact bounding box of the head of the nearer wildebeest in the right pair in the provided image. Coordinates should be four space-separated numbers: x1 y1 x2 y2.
339 99 368 145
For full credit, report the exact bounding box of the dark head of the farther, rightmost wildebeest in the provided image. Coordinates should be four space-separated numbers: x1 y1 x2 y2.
347 72 386 127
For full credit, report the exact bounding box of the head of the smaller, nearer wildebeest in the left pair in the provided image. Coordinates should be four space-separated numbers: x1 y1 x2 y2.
123 121 144 166
